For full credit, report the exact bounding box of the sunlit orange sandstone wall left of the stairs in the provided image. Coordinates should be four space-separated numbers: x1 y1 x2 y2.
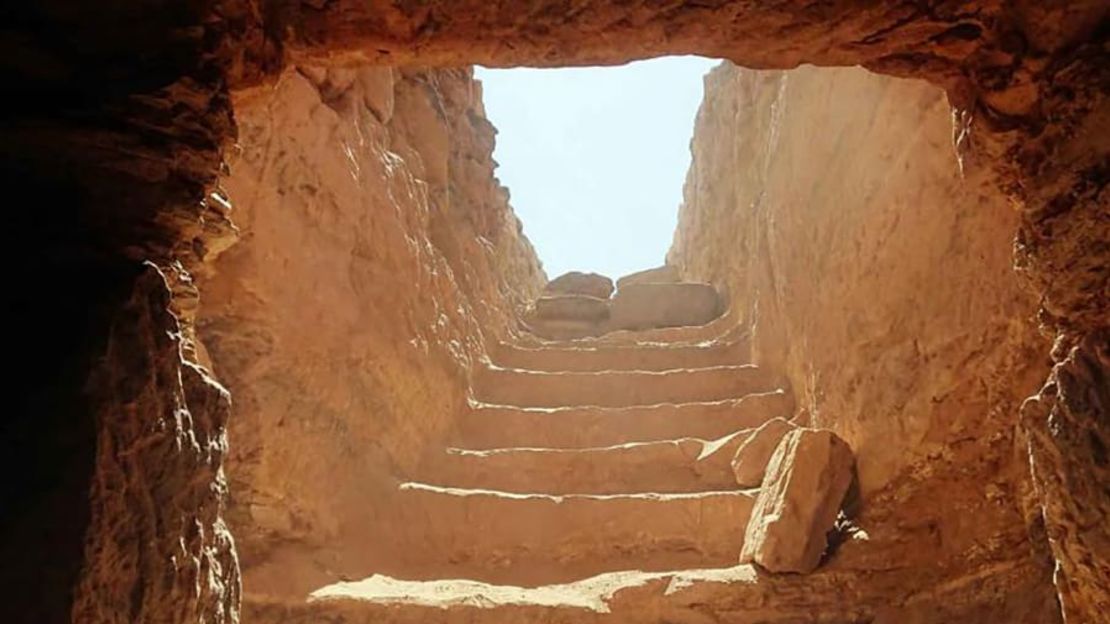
198 67 545 593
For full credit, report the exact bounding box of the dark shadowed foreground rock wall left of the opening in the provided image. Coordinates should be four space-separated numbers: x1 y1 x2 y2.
0 0 243 624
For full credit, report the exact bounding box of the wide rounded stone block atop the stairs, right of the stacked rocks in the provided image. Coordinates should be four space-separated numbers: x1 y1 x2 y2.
609 282 723 330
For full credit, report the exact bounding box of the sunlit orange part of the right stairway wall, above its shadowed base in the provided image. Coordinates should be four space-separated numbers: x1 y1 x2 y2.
668 63 1049 494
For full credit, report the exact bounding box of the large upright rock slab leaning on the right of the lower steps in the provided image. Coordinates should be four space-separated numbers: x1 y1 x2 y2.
740 429 855 573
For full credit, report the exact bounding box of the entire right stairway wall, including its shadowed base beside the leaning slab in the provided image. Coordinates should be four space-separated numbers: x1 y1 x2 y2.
668 63 1060 612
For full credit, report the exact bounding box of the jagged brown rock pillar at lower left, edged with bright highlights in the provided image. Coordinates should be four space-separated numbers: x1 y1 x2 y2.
72 265 241 624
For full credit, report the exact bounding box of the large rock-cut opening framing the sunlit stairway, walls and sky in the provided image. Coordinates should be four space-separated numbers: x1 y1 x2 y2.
198 58 1051 622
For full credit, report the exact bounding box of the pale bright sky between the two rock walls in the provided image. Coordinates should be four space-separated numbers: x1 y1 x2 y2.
477 57 717 279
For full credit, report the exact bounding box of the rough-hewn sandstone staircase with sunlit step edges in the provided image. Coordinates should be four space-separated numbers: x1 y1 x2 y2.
251 272 839 623
